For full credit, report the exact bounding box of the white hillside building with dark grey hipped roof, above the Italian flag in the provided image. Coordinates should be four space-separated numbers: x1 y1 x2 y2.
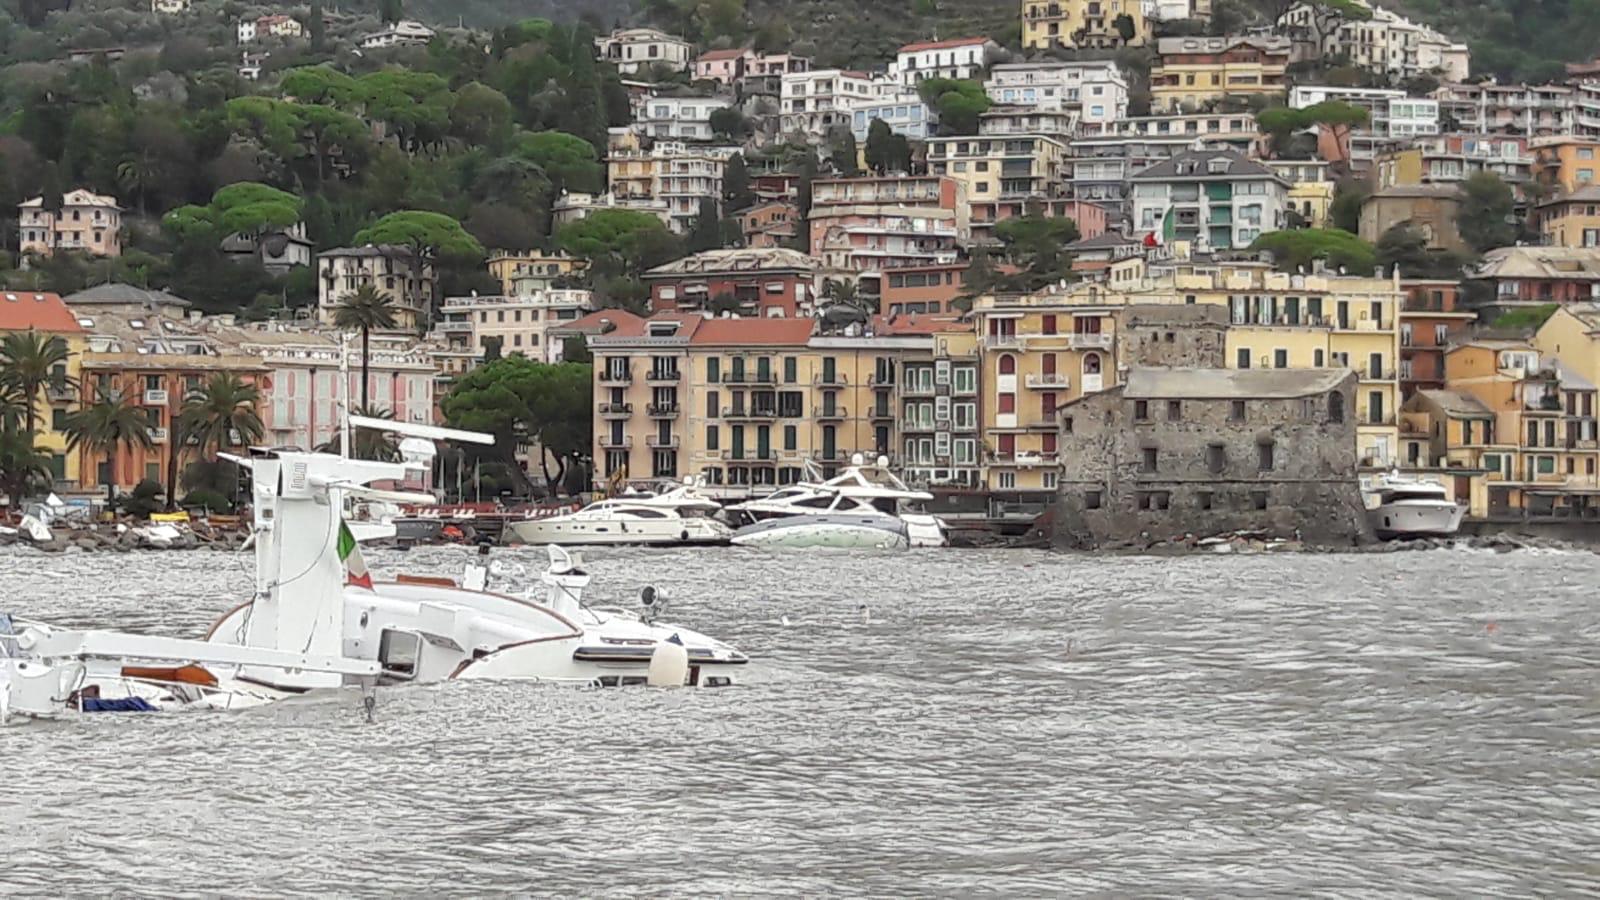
1130 151 1290 250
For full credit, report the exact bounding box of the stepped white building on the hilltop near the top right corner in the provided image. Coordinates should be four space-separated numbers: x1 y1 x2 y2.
1280 0 1472 82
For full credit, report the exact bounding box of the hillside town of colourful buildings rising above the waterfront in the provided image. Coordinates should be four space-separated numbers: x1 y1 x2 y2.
9 0 1600 546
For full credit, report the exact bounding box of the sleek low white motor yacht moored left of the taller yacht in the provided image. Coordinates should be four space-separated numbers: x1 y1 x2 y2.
510 484 733 546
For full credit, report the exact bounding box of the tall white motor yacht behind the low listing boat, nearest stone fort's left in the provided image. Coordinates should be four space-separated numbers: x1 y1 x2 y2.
728 453 946 548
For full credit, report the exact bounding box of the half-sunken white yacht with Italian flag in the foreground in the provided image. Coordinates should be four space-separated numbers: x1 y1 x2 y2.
0 416 747 722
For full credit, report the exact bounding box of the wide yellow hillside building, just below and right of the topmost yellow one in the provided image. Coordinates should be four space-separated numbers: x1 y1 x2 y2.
1150 35 1293 114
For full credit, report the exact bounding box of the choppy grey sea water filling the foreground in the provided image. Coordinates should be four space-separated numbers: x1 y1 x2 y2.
0 549 1600 897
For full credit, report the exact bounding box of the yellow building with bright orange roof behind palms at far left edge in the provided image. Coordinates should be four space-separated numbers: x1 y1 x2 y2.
0 291 88 488
